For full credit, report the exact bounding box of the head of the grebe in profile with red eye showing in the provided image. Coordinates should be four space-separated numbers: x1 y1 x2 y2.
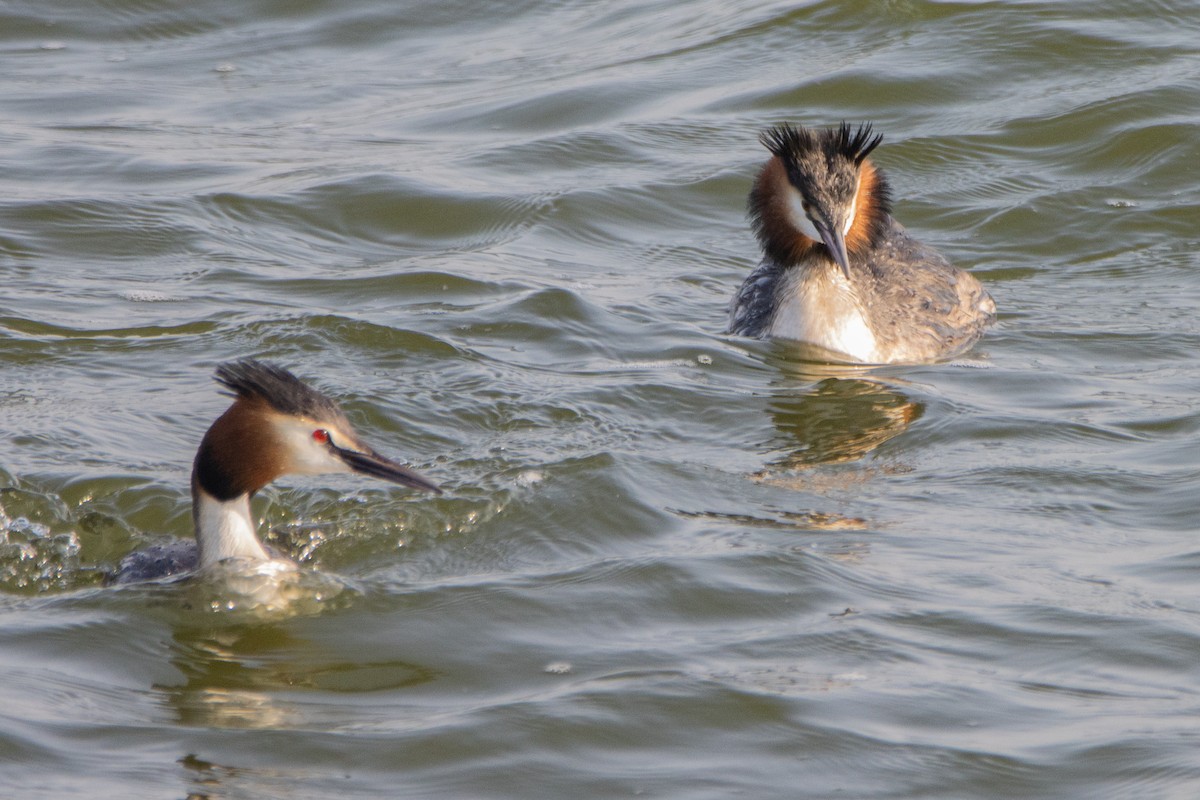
193 359 442 501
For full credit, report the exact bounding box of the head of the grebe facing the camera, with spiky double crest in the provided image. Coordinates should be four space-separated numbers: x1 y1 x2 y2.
750 122 890 278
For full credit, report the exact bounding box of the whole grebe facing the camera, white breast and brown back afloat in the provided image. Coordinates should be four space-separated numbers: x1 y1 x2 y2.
728 122 996 363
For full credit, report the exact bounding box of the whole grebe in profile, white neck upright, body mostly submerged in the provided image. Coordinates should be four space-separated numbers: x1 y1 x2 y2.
114 359 442 583
